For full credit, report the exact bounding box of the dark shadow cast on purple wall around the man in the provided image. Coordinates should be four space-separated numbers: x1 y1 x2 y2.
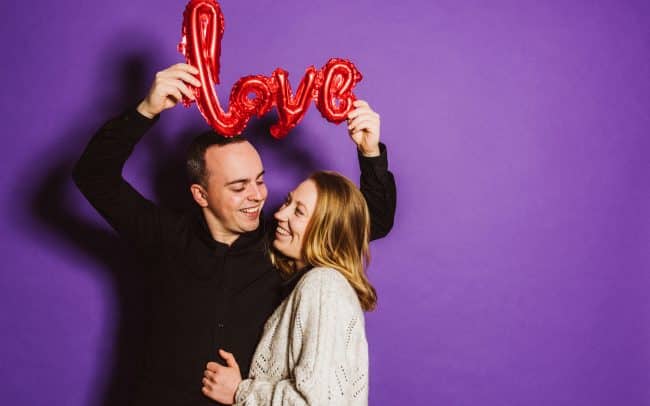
17 38 325 406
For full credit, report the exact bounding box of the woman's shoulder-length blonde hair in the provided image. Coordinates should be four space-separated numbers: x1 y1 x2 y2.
271 171 377 311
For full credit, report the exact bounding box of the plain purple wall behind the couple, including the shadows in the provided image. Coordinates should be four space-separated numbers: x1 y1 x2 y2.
0 0 650 406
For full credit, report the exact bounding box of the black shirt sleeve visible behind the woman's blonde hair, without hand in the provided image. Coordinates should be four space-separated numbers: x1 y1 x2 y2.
358 143 397 240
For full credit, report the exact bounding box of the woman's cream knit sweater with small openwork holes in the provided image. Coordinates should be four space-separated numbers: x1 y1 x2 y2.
235 268 368 406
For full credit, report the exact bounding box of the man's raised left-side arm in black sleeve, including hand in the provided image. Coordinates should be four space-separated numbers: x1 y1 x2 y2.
72 64 200 246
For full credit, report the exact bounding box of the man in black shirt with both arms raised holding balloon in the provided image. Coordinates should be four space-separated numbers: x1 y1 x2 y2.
73 64 395 405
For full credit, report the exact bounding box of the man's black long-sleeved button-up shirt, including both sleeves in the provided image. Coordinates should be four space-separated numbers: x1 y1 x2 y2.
73 110 396 406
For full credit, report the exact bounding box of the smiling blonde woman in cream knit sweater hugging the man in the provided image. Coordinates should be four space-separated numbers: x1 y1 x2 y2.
203 172 377 405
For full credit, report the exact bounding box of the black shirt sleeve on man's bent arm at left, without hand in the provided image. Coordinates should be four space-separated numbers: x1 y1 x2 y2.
72 110 172 254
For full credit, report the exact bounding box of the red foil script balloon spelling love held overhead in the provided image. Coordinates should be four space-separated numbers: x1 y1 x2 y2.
178 0 362 139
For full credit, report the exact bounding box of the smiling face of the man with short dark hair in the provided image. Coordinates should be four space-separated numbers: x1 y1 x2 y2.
205 142 268 240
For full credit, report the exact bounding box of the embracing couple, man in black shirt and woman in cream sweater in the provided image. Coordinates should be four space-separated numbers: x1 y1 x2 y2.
73 64 396 406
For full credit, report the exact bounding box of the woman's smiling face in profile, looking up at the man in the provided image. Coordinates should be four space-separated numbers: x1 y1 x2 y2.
273 179 318 268
